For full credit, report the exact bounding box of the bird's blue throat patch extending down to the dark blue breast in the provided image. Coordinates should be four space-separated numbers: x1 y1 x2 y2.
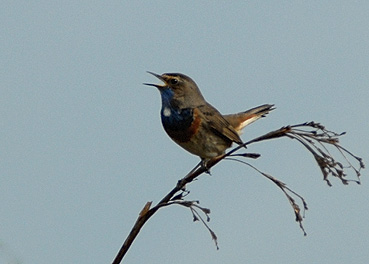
160 88 193 131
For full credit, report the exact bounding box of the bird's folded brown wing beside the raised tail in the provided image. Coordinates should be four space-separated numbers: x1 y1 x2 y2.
197 104 243 144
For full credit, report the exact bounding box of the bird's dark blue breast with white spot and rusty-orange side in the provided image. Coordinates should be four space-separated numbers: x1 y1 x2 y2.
161 106 201 142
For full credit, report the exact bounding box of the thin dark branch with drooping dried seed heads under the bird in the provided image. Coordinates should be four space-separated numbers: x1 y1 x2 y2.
113 122 365 264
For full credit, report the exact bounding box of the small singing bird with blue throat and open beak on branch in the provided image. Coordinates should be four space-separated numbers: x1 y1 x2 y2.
144 71 274 167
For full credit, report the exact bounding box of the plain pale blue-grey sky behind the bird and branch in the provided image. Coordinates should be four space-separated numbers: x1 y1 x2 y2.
0 0 369 264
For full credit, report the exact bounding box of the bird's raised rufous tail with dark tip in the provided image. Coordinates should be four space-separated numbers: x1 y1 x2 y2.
224 104 275 134
